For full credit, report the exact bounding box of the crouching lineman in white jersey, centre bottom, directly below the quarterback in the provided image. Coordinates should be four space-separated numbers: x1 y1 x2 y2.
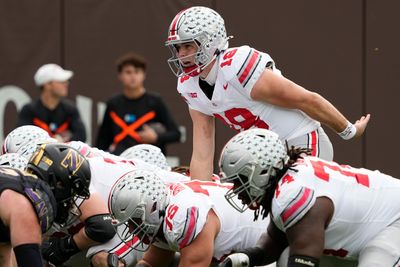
109 170 276 267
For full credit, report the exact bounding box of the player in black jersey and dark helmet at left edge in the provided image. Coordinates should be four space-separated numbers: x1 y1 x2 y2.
0 143 90 267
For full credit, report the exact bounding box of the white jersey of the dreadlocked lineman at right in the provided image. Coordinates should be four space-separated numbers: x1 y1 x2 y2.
271 157 400 258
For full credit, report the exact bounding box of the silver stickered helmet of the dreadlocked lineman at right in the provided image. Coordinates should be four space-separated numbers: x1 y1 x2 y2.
219 128 289 212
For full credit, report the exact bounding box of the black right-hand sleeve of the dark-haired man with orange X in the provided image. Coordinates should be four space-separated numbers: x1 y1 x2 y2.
157 98 181 144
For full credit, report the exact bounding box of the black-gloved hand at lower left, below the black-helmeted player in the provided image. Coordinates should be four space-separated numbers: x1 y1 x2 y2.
41 236 79 266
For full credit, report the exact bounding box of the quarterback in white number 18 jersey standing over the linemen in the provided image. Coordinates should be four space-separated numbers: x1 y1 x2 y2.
166 6 369 182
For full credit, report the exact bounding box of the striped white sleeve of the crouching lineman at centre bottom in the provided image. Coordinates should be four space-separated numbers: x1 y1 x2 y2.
163 193 212 251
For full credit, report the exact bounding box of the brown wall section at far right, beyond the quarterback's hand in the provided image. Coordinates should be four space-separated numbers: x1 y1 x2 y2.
365 0 400 177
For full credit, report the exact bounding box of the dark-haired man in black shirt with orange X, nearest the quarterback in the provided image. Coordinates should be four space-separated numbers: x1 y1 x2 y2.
96 53 180 155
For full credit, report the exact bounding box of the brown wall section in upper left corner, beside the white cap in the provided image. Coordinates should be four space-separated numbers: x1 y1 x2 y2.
0 0 61 134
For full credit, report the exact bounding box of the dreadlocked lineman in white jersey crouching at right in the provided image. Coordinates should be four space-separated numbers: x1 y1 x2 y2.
220 129 400 267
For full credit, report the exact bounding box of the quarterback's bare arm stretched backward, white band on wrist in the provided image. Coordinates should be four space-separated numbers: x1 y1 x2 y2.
251 69 370 139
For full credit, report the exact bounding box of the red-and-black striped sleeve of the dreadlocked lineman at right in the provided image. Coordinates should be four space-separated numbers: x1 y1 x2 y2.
272 177 316 232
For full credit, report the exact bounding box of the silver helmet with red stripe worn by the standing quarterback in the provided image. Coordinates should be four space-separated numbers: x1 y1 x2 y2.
165 6 230 77
